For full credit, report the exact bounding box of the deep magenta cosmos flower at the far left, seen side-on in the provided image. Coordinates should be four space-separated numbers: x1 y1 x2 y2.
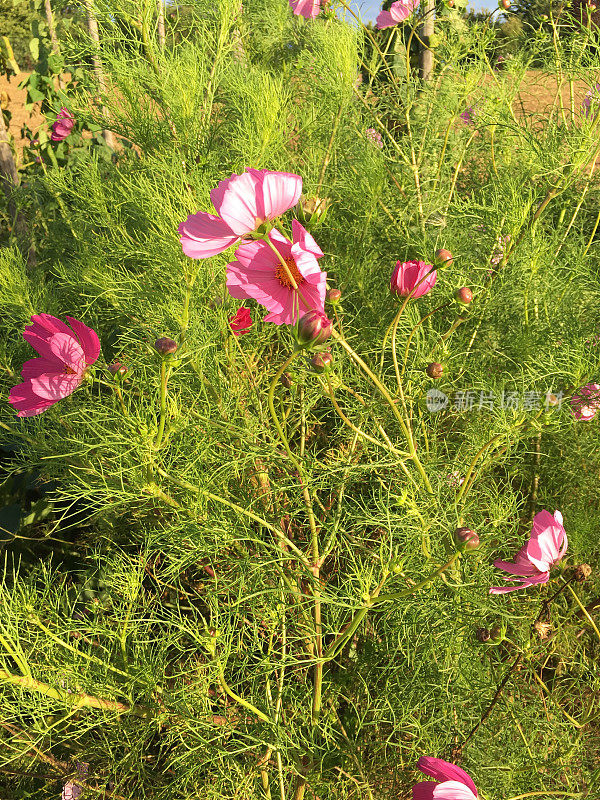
8 314 100 417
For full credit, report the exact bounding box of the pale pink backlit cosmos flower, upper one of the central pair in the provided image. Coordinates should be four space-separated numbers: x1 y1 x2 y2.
178 169 302 258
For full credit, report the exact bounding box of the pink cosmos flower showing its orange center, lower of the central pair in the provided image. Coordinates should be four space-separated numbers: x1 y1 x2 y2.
227 220 327 325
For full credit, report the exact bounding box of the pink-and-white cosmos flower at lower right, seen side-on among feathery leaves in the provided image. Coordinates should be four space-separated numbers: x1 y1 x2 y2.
490 511 568 594
